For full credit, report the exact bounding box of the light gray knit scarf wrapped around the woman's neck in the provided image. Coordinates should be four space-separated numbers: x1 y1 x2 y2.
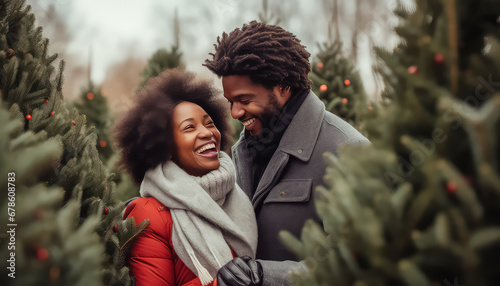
140 152 257 285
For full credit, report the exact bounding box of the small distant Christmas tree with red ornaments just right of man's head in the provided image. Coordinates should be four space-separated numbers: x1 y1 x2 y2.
309 41 373 129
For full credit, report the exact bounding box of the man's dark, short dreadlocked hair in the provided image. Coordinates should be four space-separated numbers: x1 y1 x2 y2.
204 21 311 92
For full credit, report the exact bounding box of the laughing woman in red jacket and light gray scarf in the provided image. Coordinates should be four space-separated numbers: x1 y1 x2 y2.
117 70 257 286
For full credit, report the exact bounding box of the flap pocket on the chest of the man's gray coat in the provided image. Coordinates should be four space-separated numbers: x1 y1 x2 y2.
264 179 312 204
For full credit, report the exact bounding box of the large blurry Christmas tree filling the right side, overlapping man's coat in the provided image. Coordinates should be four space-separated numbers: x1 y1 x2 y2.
282 0 500 286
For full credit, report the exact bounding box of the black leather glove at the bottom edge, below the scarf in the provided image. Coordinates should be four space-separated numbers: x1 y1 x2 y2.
217 256 262 286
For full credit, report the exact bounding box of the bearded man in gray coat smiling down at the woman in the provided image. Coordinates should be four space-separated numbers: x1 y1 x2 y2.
204 21 368 285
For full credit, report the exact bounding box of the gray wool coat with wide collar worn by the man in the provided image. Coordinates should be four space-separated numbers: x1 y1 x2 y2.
231 91 369 285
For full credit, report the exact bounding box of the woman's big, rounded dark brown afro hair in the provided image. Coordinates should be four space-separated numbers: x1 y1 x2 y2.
115 69 232 184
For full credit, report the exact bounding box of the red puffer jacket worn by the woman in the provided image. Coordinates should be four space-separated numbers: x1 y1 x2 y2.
124 197 234 286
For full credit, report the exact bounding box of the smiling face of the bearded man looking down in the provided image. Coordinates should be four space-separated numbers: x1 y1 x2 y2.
222 75 291 137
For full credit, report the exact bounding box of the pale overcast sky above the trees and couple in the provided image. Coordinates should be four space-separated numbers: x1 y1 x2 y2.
27 0 402 101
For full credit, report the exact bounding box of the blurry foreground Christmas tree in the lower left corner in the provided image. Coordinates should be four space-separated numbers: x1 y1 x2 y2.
0 101 104 285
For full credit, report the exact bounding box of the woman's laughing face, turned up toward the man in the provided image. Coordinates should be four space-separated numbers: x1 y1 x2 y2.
172 101 221 176
